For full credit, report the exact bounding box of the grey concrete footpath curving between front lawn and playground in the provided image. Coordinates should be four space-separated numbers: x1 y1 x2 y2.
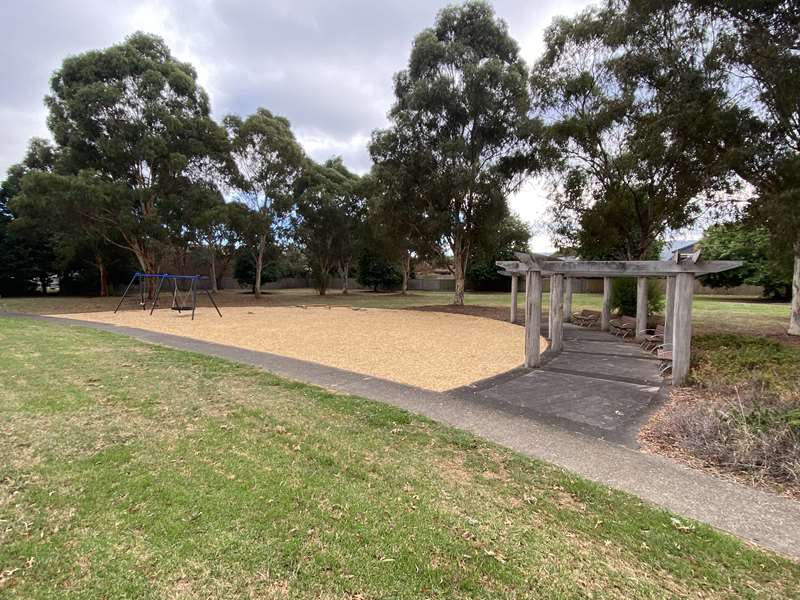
6 313 800 560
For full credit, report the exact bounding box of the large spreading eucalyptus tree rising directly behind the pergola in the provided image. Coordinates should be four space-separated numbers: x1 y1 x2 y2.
531 0 743 259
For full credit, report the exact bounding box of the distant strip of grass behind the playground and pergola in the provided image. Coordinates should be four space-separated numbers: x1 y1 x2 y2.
0 289 789 336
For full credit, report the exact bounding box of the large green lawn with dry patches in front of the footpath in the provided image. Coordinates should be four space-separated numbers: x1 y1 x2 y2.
0 319 800 598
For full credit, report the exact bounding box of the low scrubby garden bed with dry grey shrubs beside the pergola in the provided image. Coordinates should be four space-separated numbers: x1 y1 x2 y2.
644 333 800 494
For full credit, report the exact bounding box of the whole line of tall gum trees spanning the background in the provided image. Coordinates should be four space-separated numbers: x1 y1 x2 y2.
0 0 800 334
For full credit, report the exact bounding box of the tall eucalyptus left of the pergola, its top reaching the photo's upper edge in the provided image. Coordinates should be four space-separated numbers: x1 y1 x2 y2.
389 1 530 304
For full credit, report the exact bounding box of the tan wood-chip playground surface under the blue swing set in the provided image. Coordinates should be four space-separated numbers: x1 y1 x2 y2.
51 307 547 391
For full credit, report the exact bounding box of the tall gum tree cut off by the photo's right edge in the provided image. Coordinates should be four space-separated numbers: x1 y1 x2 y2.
616 0 800 335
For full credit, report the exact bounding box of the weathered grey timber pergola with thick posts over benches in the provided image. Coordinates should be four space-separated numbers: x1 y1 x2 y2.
495 252 742 385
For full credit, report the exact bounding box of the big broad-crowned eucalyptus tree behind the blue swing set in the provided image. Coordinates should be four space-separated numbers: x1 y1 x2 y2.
45 33 226 273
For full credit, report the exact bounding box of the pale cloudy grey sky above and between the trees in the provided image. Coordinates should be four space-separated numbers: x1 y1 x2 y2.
0 0 589 251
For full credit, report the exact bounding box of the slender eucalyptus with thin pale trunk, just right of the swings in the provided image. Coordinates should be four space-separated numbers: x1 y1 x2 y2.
224 108 305 297
